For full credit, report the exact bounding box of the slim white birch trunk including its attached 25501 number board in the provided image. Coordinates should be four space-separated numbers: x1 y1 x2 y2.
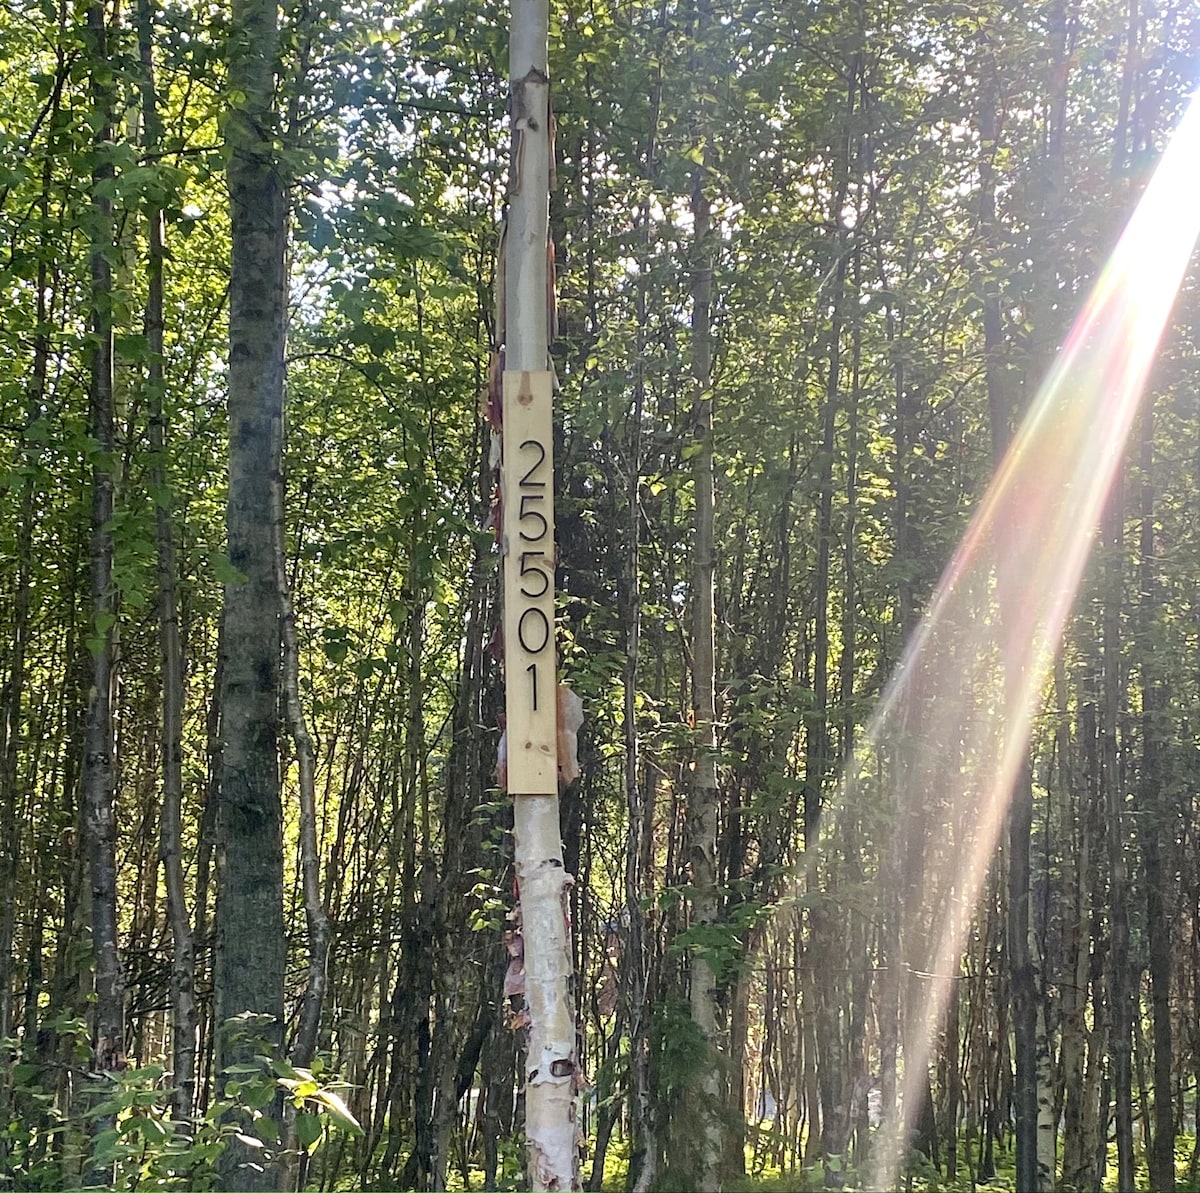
498 0 580 1189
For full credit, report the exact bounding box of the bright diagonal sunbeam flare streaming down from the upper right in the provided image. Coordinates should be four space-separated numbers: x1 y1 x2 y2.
777 88 1200 1188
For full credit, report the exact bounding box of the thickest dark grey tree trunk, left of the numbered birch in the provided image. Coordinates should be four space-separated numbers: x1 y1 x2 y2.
214 0 287 1189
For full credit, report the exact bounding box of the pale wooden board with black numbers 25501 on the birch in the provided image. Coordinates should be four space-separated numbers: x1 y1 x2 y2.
500 371 558 796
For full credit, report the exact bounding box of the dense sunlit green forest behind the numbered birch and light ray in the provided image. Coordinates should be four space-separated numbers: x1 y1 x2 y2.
0 0 1200 1191
